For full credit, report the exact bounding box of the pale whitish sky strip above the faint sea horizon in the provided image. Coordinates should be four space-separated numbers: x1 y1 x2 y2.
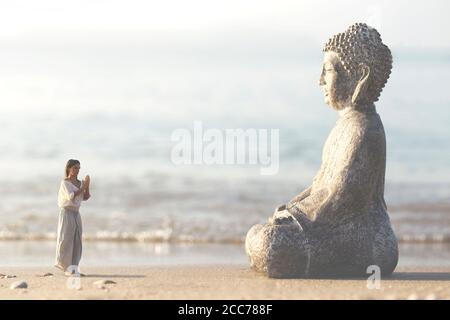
0 0 450 47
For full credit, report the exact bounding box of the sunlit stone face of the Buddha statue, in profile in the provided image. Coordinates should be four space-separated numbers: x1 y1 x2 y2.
319 51 354 110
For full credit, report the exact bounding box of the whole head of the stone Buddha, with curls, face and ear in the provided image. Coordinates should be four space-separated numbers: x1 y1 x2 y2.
319 23 392 110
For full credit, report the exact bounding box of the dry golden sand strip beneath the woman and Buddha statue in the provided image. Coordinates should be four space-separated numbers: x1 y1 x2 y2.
0 266 450 300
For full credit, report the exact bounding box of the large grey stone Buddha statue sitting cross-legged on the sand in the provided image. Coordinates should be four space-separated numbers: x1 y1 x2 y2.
245 23 398 278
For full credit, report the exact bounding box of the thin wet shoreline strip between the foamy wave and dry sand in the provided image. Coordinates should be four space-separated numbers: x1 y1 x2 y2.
0 240 450 270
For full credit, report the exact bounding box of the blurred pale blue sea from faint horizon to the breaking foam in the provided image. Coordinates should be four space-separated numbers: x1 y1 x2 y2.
0 39 450 266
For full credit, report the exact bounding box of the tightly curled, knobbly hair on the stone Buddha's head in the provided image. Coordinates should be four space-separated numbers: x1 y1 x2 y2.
323 23 392 102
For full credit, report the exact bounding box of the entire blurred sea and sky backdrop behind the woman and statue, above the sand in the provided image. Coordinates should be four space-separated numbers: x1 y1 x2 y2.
0 0 450 266
